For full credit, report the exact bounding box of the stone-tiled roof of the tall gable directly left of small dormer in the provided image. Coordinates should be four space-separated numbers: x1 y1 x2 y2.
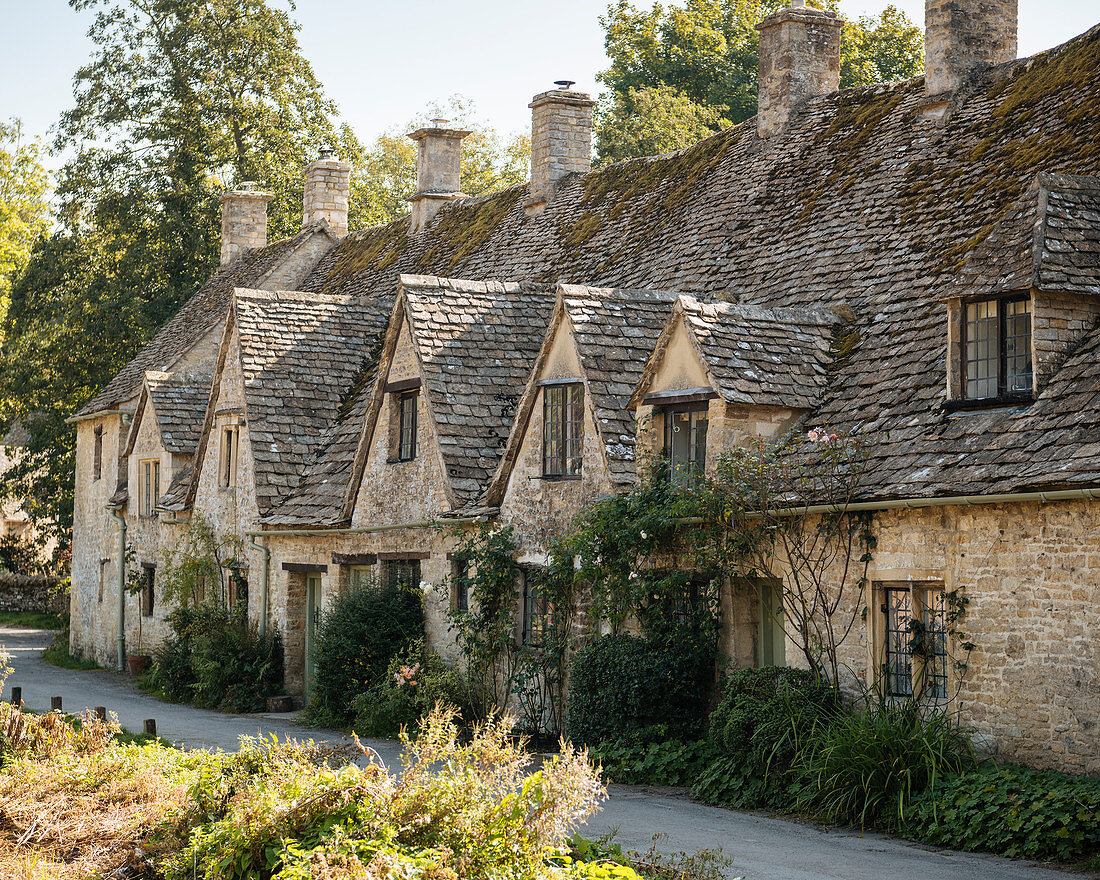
559 284 677 485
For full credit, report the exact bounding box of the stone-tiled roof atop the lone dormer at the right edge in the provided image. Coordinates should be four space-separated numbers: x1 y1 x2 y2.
954 173 1100 296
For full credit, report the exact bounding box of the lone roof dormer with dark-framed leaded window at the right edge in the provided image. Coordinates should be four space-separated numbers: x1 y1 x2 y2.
947 174 1100 409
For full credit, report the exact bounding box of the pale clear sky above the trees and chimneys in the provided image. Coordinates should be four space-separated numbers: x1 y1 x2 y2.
0 0 1100 167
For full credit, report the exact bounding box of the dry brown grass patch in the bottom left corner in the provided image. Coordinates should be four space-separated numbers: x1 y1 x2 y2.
0 706 187 880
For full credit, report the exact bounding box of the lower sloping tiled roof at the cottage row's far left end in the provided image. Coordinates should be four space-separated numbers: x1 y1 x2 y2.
76 226 317 417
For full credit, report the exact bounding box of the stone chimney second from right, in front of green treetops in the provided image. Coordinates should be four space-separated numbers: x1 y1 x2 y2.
757 0 840 138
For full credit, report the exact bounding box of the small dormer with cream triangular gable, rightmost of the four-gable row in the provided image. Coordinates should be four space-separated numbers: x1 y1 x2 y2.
630 296 840 474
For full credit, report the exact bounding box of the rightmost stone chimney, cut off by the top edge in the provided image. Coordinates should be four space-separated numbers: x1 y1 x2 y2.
924 0 1016 98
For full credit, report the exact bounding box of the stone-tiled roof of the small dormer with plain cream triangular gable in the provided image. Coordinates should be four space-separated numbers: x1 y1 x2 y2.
675 296 840 409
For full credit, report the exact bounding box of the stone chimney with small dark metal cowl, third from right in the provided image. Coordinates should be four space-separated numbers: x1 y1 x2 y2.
525 79 595 216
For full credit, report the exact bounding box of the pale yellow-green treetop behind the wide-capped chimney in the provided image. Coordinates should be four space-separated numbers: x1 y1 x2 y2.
349 96 530 228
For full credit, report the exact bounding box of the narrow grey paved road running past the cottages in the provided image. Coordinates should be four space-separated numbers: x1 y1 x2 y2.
0 627 1084 880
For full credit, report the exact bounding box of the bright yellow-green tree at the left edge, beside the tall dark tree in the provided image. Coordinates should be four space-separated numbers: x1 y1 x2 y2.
0 119 50 322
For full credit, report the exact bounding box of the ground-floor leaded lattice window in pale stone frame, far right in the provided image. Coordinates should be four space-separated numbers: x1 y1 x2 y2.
881 584 948 700
